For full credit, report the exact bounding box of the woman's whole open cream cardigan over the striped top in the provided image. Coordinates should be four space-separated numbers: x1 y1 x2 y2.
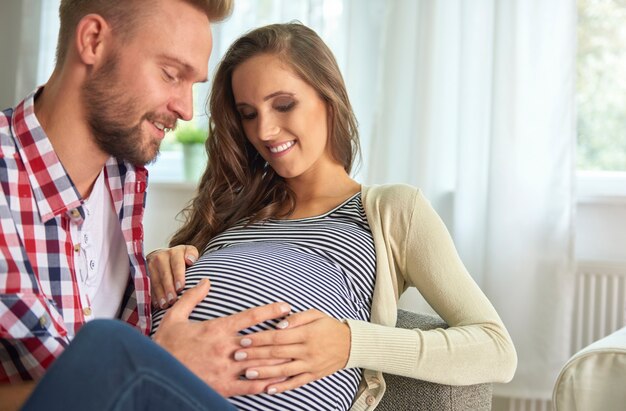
346 184 517 411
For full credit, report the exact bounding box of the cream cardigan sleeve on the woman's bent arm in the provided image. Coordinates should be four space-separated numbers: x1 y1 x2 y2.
347 189 517 385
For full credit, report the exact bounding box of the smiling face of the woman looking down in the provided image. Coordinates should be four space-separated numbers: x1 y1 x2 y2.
232 54 337 183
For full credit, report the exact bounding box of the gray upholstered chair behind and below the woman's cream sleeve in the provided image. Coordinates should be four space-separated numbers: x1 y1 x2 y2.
376 310 492 411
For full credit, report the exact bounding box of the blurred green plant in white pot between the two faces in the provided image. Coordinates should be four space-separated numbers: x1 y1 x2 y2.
175 124 208 182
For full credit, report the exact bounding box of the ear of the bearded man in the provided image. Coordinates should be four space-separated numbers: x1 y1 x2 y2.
75 14 111 66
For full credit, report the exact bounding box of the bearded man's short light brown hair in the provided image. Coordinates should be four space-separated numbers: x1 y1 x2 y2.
56 0 233 65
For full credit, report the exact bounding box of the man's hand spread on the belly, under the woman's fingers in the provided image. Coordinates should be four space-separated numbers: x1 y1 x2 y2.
154 279 291 397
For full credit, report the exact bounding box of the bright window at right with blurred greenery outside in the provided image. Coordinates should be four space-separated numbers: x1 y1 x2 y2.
576 0 626 172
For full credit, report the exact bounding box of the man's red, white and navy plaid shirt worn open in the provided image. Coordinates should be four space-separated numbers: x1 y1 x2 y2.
0 89 151 383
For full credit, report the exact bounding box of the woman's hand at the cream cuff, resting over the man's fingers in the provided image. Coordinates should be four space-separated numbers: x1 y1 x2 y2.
235 309 350 394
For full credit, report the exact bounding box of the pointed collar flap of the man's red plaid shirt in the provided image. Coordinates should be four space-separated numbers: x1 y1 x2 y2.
11 89 81 223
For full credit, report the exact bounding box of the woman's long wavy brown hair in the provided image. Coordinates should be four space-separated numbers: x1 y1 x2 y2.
170 23 360 252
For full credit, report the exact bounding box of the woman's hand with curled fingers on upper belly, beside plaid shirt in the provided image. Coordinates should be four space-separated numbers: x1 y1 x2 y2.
146 245 198 308
